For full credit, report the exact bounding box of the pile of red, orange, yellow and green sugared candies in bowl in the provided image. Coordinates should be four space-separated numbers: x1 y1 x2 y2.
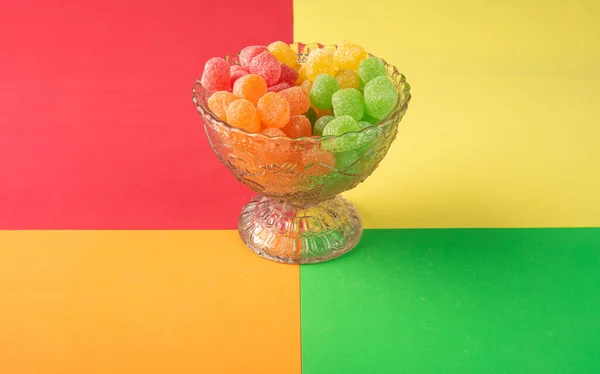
201 41 397 138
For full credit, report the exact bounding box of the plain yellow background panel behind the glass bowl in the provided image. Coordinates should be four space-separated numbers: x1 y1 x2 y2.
294 0 600 228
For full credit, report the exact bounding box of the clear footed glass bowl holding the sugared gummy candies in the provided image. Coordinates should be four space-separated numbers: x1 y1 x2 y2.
193 43 410 264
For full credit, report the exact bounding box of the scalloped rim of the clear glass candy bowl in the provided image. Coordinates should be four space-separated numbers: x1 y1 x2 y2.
192 42 412 142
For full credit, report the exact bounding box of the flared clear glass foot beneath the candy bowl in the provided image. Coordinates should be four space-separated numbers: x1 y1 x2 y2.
238 195 362 264
